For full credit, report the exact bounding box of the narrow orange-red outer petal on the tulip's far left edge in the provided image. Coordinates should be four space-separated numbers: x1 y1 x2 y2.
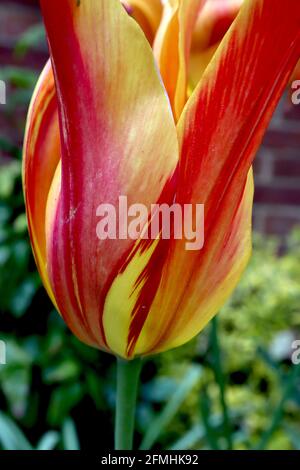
23 61 60 312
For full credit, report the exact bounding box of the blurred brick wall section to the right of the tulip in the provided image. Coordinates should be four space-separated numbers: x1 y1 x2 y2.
254 100 300 239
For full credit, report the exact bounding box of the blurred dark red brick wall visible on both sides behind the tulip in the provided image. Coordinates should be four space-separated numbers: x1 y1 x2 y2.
0 0 300 236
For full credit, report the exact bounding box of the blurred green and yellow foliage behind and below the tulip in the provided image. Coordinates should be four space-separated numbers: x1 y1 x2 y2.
0 21 300 449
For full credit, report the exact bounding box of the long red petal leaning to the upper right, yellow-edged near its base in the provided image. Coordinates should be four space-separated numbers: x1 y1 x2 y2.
119 0 300 355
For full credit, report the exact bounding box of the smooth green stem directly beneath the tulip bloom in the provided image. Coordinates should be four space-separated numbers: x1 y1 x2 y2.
115 358 142 450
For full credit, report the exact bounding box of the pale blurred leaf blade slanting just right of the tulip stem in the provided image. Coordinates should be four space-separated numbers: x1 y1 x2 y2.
140 365 202 450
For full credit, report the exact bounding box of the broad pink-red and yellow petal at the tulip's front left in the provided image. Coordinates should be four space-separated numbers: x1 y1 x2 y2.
41 0 178 349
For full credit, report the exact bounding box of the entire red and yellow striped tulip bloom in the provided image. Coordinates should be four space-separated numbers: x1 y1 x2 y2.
24 0 300 450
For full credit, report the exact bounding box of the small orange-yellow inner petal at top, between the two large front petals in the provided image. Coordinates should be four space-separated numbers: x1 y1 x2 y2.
154 0 205 120
